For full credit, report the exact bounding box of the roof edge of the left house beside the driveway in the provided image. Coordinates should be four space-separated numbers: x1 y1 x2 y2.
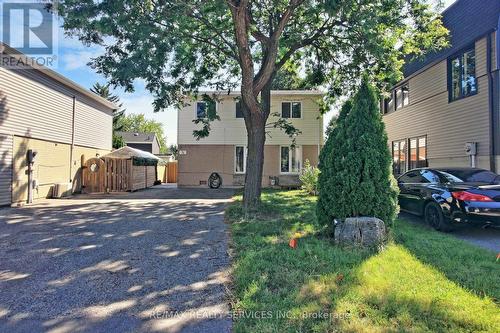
0 41 118 110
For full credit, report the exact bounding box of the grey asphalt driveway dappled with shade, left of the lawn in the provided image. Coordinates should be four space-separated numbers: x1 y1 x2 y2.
0 187 232 333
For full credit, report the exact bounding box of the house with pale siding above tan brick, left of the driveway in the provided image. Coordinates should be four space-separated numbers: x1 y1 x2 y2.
0 43 116 206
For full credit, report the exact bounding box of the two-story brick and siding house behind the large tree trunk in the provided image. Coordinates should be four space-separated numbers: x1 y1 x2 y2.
177 90 323 186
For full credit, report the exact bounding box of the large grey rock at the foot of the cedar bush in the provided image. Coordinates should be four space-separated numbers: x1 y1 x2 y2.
334 217 387 247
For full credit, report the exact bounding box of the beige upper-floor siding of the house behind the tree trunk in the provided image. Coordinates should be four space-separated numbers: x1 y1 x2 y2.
178 95 323 145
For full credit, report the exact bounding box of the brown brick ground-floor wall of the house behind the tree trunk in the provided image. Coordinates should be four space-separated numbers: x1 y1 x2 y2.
177 145 319 186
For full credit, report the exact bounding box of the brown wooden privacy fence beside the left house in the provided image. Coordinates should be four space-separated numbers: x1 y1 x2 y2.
82 158 156 193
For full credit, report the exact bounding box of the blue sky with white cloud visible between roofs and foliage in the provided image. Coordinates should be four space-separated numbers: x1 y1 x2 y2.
0 0 454 145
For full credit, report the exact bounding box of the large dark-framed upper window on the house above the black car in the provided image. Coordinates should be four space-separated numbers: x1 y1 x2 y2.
448 49 477 101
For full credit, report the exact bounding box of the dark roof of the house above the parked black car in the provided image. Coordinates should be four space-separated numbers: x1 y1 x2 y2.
403 0 500 78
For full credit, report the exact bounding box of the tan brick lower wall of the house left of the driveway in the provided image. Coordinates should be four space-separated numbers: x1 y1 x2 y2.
12 136 109 202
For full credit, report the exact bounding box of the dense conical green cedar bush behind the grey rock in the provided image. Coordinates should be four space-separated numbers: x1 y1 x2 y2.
317 78 398 228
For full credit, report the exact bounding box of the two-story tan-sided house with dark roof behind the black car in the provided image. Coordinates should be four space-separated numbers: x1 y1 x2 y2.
382 0 500 175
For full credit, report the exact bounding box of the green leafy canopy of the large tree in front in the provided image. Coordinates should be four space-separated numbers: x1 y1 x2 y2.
52 0 447 111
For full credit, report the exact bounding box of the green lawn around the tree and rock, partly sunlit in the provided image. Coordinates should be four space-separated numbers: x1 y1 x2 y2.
226 191 500 333
